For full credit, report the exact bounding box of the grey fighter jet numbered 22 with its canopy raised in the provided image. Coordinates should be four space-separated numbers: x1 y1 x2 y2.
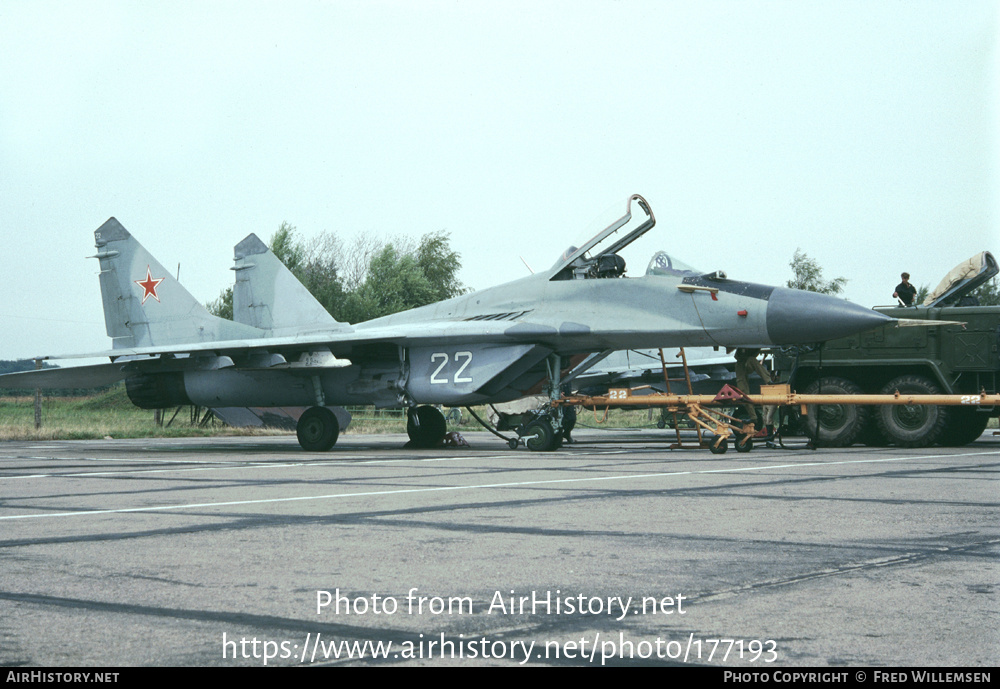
0 195 892 451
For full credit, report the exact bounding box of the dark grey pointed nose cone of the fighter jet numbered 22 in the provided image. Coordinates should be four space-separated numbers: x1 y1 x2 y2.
767 287 895 345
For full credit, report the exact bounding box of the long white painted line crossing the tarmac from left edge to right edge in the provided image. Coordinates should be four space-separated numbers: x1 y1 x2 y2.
0 452 1000 521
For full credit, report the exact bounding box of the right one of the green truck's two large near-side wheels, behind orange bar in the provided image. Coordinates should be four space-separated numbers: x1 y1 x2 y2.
876 374 949 447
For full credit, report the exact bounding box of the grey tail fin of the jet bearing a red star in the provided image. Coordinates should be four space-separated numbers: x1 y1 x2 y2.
94 218 266 348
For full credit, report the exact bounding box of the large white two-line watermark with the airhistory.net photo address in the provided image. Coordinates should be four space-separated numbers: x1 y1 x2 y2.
222 588 777 665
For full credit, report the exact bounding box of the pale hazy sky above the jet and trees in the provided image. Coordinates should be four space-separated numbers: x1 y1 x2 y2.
0 0 1000 359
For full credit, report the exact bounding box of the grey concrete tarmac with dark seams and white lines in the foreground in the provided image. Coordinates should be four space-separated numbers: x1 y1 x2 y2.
0 430 1000 671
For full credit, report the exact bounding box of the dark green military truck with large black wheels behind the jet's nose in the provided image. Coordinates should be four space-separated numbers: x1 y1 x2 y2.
775 251 1000 447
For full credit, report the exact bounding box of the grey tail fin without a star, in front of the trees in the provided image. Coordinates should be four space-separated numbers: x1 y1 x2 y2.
233 234 348 334
